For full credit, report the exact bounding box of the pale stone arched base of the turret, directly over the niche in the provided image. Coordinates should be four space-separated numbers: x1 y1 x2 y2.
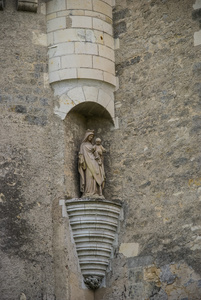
52 79 115 123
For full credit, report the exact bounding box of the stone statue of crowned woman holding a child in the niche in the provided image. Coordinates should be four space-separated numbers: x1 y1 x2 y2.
78 129 106 199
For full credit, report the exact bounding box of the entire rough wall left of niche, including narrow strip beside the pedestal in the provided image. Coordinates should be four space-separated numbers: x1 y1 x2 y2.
0 0 92 300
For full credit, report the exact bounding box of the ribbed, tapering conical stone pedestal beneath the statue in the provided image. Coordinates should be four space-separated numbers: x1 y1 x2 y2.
66 198 122 289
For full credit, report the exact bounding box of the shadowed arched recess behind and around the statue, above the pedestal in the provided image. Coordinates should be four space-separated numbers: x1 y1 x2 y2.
64 102 113 199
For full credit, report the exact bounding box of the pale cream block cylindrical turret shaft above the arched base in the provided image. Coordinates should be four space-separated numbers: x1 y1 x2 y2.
47 0 116 85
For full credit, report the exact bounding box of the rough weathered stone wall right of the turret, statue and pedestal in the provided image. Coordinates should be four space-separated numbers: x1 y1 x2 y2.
96 0 201 300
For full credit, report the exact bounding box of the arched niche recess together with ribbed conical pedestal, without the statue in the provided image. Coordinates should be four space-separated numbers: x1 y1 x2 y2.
64 102 122 290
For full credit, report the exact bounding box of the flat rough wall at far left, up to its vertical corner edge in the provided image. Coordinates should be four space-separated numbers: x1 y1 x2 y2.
0 1 54 300
